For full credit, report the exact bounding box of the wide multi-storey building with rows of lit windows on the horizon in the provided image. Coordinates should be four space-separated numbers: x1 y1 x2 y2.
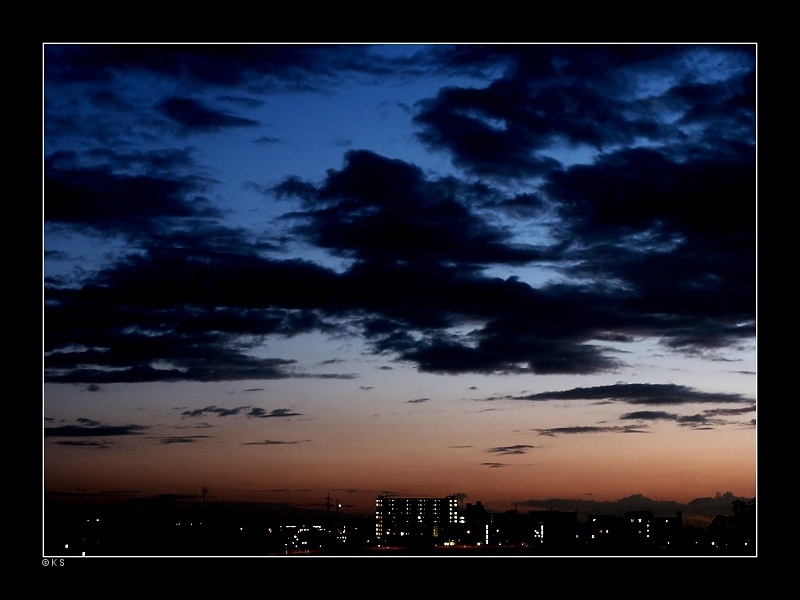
375 495 458 546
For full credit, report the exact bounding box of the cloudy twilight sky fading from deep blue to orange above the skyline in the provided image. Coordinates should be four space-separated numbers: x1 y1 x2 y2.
42 43 758 513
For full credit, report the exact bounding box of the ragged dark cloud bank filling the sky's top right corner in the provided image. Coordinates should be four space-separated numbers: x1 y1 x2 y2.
415 45 755 178
